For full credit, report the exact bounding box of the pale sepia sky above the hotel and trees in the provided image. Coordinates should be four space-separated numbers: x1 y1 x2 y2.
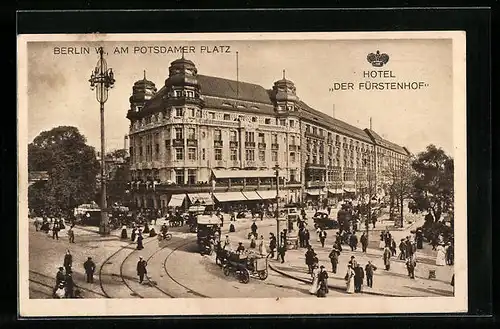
28 39 453 154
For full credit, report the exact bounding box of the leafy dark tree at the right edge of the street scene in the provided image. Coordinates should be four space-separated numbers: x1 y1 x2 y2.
412 144 454 221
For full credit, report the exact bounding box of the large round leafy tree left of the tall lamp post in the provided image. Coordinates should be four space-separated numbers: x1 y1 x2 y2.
28 126 100 213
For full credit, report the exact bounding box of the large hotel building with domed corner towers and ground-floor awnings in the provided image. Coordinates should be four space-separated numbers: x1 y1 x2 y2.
127 57 409 208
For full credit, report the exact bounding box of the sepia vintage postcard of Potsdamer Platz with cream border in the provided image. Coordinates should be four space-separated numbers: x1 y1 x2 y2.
17 31 468 317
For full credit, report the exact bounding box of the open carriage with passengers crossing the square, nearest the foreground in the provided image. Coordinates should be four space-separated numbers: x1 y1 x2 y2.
216 249 269 283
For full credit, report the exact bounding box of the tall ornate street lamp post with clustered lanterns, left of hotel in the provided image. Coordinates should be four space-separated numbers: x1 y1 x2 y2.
89 47 115 235
